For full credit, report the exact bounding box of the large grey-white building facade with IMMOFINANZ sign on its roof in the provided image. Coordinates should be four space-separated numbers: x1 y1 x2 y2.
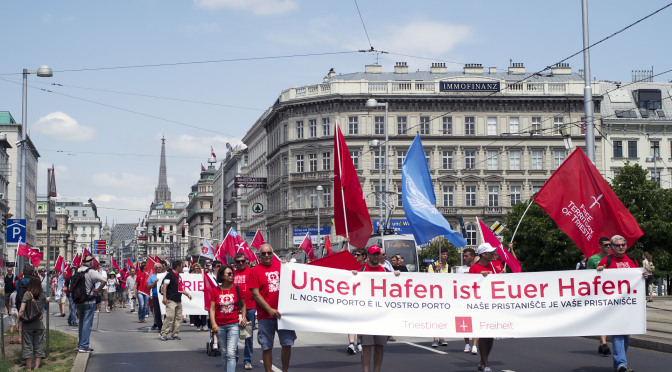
263 62 603 254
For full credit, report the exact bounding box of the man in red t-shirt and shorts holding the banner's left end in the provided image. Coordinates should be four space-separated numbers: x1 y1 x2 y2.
247 243 296 372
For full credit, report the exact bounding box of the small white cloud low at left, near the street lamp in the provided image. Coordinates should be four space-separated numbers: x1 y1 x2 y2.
32 111 98 142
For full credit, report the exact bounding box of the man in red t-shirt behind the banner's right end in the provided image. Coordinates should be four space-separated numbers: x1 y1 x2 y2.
597 235 649 372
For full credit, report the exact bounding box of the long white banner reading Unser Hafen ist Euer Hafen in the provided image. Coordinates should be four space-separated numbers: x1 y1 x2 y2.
278 263 646 338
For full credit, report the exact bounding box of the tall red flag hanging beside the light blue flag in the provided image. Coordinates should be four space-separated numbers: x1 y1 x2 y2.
334 123 373 247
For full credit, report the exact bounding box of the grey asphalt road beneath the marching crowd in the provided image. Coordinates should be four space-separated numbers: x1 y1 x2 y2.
51 304 672 372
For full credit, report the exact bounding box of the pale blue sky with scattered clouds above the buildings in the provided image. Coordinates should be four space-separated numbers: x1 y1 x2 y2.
0 0 672 223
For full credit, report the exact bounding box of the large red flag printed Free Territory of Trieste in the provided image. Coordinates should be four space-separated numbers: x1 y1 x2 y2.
534 148 644 257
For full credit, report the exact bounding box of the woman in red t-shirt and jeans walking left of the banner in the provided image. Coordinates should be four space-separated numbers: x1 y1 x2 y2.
210 266 247 372
